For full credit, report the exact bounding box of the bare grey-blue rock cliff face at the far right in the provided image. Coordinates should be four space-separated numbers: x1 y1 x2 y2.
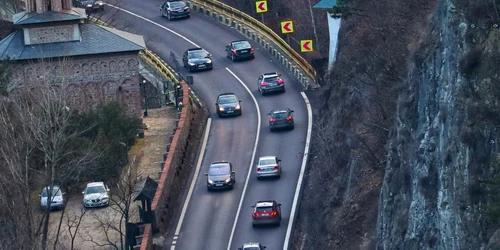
377 1 500 250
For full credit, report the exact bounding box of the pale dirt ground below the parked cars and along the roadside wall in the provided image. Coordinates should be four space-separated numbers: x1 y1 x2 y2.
45 107 177 250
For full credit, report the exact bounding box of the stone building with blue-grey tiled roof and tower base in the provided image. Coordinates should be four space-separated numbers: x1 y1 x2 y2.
0 0 146 116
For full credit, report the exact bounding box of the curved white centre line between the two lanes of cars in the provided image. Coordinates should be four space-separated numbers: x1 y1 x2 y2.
226 68 260 250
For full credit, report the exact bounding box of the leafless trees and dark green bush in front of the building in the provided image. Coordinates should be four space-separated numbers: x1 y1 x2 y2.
0 67 141 249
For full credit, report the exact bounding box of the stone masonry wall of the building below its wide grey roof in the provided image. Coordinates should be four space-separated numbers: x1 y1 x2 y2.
12 53 141 117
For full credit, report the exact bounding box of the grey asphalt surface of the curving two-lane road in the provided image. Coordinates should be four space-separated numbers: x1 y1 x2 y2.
95 0 308 250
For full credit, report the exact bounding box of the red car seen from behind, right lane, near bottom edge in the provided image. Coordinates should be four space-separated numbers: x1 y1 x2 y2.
252 200 281 227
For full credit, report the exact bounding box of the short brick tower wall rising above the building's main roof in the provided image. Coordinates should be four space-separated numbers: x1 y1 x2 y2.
27 24 78 44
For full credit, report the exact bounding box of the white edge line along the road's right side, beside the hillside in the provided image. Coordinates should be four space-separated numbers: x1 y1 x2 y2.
283 92 312 250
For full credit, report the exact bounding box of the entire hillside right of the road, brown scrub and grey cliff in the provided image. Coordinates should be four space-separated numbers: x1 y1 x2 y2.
294 0 500 250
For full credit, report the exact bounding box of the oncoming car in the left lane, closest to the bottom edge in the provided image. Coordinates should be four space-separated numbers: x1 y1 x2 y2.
205 161 236 191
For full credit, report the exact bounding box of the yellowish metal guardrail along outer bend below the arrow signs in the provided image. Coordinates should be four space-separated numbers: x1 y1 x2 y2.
190 0 316 80
